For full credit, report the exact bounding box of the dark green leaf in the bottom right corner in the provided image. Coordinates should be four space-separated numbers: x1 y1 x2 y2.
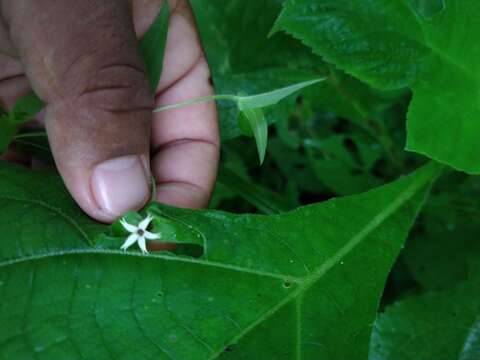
369 282 480 360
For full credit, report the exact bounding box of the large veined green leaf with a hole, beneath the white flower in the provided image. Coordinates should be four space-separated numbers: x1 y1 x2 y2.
0 163 439 360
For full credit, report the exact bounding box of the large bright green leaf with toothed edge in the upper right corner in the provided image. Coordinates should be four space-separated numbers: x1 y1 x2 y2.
275 0 480 174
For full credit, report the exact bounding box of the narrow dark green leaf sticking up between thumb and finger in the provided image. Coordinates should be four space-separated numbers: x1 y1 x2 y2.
140 1 170 92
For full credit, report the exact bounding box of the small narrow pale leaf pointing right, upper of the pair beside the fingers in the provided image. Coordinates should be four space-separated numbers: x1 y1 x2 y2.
237 78 325 111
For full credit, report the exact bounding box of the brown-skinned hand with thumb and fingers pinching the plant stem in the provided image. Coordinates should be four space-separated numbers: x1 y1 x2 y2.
0 0 220 222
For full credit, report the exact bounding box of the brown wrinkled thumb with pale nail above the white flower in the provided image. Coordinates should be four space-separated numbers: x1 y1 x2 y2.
2 0 153 222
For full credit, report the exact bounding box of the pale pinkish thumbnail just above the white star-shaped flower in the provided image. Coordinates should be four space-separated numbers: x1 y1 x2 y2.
91 155 150 216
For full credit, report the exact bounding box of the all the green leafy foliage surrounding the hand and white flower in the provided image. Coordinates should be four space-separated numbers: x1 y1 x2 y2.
0 0 480 360
